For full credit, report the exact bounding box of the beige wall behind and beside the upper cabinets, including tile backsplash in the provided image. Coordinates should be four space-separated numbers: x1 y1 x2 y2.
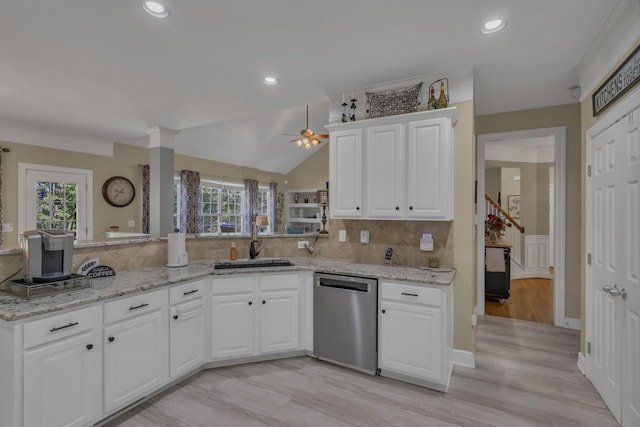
285 102 476 351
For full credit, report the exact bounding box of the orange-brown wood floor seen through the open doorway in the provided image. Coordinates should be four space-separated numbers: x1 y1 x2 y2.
484 278 553 325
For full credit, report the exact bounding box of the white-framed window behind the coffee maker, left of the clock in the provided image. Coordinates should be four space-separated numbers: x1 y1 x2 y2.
18 163 93 240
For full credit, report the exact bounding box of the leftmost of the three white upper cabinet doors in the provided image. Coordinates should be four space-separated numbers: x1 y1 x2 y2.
329 129 363 218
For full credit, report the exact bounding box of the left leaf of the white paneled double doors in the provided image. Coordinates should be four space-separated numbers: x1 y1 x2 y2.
587 126 621 422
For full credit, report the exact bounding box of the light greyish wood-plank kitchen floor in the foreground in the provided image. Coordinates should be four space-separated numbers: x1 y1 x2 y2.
101 316 617 427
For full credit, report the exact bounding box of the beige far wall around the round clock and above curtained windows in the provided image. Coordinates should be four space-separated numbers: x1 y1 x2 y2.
2 142 284 244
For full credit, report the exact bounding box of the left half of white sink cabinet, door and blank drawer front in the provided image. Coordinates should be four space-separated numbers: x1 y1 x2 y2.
211 275 257 360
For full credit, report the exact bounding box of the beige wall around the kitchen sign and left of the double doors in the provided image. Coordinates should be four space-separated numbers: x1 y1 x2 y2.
580 41 640 354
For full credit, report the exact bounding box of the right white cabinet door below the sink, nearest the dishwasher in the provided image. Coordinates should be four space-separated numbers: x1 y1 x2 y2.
260 289 300 353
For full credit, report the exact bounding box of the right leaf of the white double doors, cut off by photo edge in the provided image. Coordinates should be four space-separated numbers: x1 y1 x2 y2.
618 108 640 426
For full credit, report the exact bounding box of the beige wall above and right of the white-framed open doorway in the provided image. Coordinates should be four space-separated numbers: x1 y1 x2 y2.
476 104 582 319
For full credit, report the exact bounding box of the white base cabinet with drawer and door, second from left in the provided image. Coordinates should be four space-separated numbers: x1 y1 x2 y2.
104 289 169 414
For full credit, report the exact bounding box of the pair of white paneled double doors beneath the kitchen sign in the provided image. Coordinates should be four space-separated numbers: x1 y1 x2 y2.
587 102 640 426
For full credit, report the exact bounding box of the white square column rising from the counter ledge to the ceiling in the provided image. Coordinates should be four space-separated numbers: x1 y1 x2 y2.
147 127 179 236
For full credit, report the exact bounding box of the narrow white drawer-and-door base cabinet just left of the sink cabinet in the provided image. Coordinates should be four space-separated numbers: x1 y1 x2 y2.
169 279 209 379
